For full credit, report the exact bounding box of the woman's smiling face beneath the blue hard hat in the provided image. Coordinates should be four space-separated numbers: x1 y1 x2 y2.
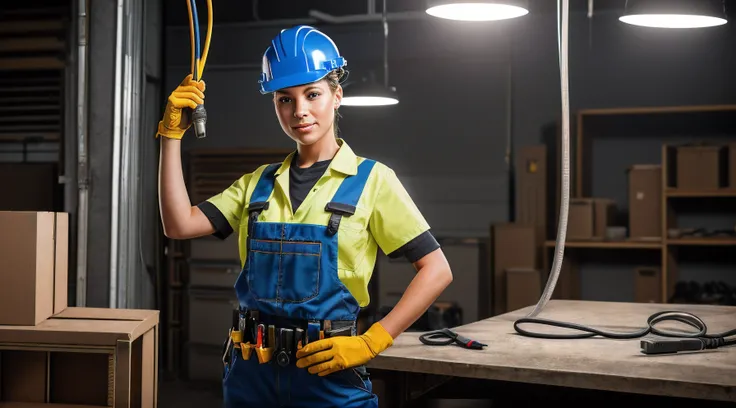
273 80 342 145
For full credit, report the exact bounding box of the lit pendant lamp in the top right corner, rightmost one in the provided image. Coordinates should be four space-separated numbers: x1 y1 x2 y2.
619 0 727 28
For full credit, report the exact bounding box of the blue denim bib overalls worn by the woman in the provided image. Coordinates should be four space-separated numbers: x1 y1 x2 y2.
223 159 378 408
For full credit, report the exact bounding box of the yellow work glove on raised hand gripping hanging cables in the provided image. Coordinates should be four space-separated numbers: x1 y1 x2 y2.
156 74 205 139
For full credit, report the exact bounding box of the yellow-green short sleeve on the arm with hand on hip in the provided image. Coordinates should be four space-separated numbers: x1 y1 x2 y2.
369 168 429 254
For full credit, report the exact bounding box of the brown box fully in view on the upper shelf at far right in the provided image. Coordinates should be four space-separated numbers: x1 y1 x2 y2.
676 145 727 190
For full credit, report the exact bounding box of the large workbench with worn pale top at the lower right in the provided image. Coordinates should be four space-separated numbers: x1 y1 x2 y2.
368 300 736 407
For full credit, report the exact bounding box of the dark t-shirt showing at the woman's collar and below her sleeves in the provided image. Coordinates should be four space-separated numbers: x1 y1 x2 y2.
198 154 440 263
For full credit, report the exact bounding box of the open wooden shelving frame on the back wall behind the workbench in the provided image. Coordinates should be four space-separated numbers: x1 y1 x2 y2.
544 105 736 303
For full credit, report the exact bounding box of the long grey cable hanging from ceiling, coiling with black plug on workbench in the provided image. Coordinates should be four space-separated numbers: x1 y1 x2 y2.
514 0 736 354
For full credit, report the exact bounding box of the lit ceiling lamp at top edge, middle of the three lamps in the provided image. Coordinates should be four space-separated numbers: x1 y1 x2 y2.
427 0 529 21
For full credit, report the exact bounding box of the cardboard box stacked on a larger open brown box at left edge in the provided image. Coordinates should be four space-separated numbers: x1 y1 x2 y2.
0 211 159 408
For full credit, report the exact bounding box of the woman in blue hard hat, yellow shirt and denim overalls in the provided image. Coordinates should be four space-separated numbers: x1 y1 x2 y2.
158 26 452 407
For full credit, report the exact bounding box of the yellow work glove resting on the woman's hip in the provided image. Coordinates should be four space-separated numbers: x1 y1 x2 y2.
296 323 394 377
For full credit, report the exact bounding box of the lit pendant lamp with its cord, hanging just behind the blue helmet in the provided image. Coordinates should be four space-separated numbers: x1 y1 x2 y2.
341 0 399 106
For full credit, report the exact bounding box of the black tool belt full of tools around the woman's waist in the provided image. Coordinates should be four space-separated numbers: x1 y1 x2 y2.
222 310 357 367
